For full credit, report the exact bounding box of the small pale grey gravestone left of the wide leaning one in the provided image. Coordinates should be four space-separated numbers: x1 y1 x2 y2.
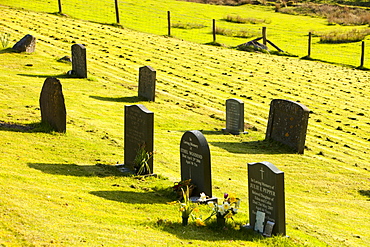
222 99 246 135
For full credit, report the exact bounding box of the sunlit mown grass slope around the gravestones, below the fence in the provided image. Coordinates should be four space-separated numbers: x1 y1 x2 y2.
0 3 370 246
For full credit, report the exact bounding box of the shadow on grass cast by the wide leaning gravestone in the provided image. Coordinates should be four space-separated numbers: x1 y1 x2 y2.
210 140 296 154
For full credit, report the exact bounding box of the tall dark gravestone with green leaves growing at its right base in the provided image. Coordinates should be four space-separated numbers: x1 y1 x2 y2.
124 105 154 173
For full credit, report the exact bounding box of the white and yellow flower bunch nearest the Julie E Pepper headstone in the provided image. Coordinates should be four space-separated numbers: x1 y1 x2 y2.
206 193 241 227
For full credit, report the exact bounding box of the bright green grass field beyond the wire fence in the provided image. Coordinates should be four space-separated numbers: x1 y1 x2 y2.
0 0 370 67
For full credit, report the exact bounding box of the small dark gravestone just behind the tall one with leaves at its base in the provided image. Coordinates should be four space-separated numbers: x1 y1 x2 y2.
138 66 156 101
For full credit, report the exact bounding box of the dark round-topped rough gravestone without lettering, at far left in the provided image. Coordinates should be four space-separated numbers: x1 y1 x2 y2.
39 77 67 132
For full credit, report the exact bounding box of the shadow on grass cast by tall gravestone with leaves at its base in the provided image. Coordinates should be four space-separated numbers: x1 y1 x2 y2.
28 163 126 177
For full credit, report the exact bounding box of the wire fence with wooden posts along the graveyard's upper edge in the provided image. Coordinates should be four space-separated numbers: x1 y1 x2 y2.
0 0 370 67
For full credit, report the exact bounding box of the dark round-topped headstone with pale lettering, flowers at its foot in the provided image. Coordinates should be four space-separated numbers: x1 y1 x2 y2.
180 130 212 197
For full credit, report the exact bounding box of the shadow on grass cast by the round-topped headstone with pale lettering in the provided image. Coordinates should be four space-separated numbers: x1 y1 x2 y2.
89 190 168 204
